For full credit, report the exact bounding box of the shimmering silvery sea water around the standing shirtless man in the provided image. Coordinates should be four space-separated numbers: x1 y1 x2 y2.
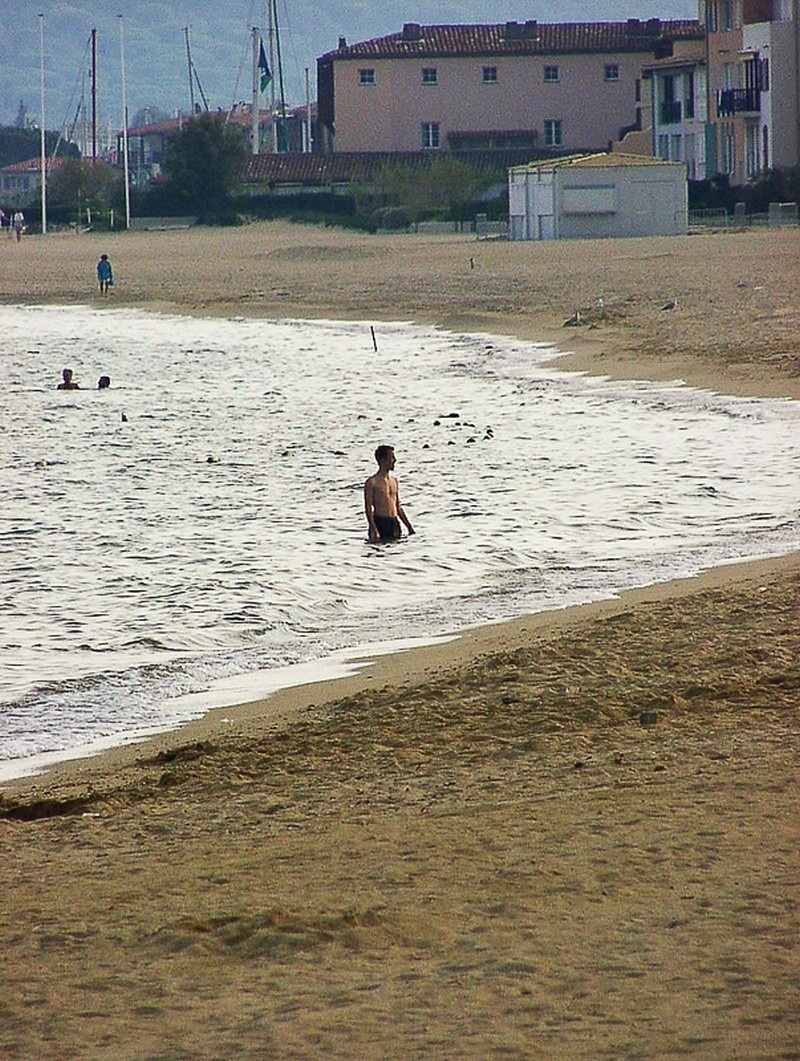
0 307 800 778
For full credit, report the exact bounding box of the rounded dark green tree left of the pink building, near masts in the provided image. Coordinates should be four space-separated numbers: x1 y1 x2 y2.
164 114 247 221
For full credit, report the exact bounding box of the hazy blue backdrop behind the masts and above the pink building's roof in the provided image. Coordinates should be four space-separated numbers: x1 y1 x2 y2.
0 0 697 128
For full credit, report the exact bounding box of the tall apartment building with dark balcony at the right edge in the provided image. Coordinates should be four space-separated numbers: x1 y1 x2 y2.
700 0 800 185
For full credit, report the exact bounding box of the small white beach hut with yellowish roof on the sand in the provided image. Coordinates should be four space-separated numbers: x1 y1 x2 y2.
508 153 689 240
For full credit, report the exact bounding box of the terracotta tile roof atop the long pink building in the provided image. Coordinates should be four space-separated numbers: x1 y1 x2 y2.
323 19 705 59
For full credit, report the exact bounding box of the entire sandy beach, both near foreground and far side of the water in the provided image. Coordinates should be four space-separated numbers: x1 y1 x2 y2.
0 223 800 1059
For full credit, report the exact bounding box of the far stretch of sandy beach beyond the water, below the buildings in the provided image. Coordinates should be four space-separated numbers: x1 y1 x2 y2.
0 222 800 400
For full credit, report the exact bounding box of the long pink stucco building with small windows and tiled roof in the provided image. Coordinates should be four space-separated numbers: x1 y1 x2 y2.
317 19 703 152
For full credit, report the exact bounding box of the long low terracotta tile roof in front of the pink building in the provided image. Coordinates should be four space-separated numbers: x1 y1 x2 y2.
244 147 568 186
